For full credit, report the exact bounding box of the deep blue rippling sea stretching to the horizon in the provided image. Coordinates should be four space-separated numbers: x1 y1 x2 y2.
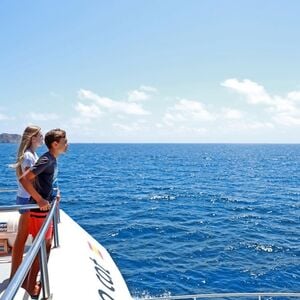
0 144 300 296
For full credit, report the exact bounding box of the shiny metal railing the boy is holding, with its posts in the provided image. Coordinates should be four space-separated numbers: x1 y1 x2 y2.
0 200 59 300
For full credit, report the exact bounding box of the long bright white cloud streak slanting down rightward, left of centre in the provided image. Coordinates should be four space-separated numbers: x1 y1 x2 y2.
78 89 150 115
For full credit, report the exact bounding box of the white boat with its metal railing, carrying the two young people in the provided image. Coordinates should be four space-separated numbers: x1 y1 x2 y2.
0 201 132 300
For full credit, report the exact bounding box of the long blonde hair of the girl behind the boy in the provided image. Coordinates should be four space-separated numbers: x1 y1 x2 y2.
11 125 41 177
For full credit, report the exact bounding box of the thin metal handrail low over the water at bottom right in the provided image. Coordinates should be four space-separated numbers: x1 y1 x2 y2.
141 292 300 300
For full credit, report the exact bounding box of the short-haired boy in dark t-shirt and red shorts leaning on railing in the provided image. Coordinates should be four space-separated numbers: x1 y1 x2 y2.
19 129 68 297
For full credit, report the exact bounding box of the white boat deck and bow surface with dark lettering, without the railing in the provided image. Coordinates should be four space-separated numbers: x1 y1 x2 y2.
0 210 132 300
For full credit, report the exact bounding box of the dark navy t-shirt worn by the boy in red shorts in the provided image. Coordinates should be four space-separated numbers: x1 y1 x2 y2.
30 152 58 211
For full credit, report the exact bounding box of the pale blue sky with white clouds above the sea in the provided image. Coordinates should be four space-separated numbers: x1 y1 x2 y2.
0 0 300 143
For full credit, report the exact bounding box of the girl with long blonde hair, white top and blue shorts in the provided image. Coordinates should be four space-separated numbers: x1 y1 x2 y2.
10 125 43 278
